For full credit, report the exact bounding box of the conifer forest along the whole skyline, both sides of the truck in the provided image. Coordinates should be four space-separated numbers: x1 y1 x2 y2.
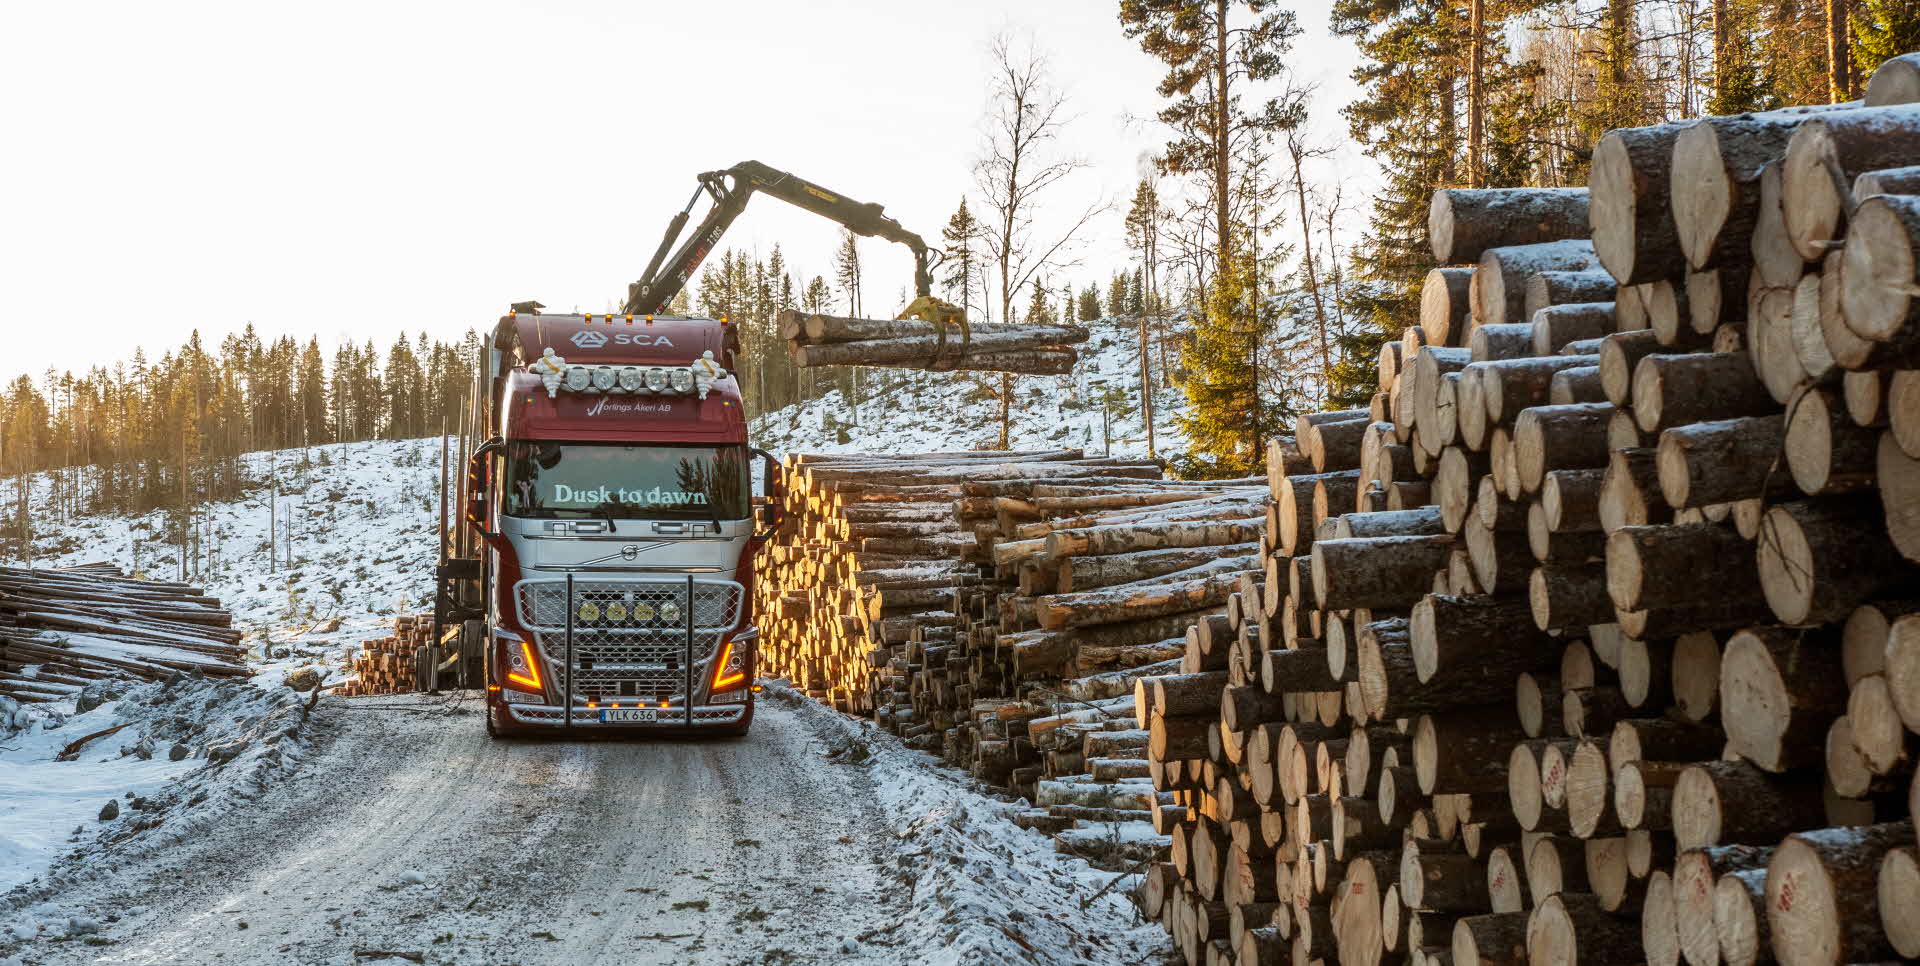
0 0 1920 514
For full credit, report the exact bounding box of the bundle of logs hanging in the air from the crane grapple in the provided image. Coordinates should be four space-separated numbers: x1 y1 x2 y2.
780 309 1089 376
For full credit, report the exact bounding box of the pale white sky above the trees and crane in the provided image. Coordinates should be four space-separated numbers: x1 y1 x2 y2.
0 0 1357 386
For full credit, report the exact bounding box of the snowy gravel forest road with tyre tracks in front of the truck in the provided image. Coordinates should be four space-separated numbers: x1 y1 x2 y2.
31 697 904 964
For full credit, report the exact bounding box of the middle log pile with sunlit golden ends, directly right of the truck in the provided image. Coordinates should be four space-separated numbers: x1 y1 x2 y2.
756 451 1265 868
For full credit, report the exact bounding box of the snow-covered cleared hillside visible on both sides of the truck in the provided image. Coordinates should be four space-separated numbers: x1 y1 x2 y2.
6 319 1185 637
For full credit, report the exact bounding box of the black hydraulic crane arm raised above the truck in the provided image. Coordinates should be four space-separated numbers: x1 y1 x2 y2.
622 161 933 315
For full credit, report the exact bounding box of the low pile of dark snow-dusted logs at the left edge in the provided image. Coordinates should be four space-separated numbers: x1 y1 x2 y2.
0 563 250 703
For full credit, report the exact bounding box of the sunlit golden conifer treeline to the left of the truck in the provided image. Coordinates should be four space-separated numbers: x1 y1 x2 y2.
0 325 480 526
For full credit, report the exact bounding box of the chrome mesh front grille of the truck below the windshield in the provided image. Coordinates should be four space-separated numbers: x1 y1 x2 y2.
518 578 745 701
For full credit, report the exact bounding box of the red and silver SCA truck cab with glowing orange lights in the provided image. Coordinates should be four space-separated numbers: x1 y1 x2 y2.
436 313 778 736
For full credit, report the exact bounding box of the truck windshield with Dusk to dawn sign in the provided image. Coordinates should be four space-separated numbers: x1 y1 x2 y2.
505 442 751 520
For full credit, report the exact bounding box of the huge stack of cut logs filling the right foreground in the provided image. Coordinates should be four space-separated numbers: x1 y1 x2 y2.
1135 56 1920 966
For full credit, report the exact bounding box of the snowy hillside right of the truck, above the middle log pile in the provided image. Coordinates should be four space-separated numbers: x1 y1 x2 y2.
753 319 1187 457
